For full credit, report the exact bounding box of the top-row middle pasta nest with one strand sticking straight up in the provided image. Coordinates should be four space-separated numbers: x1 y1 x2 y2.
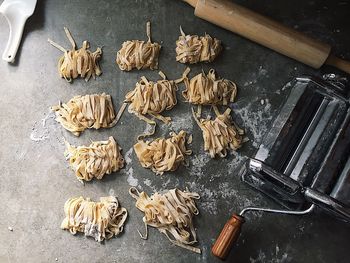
116 22 161 71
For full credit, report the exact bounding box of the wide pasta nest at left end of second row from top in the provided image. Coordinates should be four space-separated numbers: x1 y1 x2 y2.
51 93 118 136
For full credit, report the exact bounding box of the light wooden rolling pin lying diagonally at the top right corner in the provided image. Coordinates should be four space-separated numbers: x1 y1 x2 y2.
183 0 350 74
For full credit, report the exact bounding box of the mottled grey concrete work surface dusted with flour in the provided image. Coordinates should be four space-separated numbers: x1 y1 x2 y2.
0 0 350 263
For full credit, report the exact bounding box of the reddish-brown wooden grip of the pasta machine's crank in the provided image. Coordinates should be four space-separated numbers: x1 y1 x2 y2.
211 214 244 260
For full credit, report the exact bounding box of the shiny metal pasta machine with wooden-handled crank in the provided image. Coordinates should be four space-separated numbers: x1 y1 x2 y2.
212 75 350 259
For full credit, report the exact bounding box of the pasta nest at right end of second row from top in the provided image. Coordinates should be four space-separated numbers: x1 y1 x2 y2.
182 69 237 105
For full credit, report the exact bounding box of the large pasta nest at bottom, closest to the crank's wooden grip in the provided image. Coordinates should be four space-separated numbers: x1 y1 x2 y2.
129 187 201 254
